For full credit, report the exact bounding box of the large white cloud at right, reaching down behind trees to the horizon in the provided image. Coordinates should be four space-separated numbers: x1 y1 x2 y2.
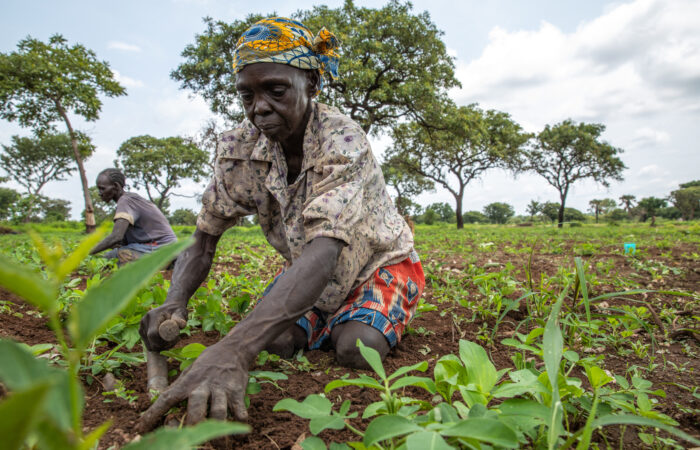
432 0 700 212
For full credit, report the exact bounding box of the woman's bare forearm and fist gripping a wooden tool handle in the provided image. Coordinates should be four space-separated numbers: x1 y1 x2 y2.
139 228 221 351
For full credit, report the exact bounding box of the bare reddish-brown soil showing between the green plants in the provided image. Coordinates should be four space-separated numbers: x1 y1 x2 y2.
0 244 700 449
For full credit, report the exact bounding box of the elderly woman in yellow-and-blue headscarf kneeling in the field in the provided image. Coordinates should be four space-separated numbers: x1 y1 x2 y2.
135 17 425 429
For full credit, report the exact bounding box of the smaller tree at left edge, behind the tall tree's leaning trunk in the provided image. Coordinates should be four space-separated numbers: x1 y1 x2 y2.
0 133 95 195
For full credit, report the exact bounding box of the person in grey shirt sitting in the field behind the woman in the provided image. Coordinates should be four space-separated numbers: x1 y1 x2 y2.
90 169 177 266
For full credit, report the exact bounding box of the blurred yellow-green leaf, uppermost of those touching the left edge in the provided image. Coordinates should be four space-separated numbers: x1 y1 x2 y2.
0 255 56 312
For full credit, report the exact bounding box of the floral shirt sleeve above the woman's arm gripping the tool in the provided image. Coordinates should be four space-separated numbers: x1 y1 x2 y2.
197 135 256 236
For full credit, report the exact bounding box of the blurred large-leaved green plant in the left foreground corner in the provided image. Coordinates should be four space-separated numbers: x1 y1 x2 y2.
0 227 248 450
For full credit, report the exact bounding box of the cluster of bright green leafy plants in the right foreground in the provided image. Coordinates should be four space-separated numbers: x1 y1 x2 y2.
274 286 700 450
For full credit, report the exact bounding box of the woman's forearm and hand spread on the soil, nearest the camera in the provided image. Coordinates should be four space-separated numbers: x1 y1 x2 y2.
139 237 345 432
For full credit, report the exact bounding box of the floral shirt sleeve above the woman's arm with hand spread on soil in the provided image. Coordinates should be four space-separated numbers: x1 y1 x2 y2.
302 128 376 244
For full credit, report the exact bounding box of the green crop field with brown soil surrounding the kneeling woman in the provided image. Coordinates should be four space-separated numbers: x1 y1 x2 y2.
0 224 700 449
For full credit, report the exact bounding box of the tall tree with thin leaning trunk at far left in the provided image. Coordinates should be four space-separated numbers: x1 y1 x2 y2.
0 34 126 232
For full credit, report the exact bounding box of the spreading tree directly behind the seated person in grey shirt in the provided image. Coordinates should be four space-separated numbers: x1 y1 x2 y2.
115 135 209 213
